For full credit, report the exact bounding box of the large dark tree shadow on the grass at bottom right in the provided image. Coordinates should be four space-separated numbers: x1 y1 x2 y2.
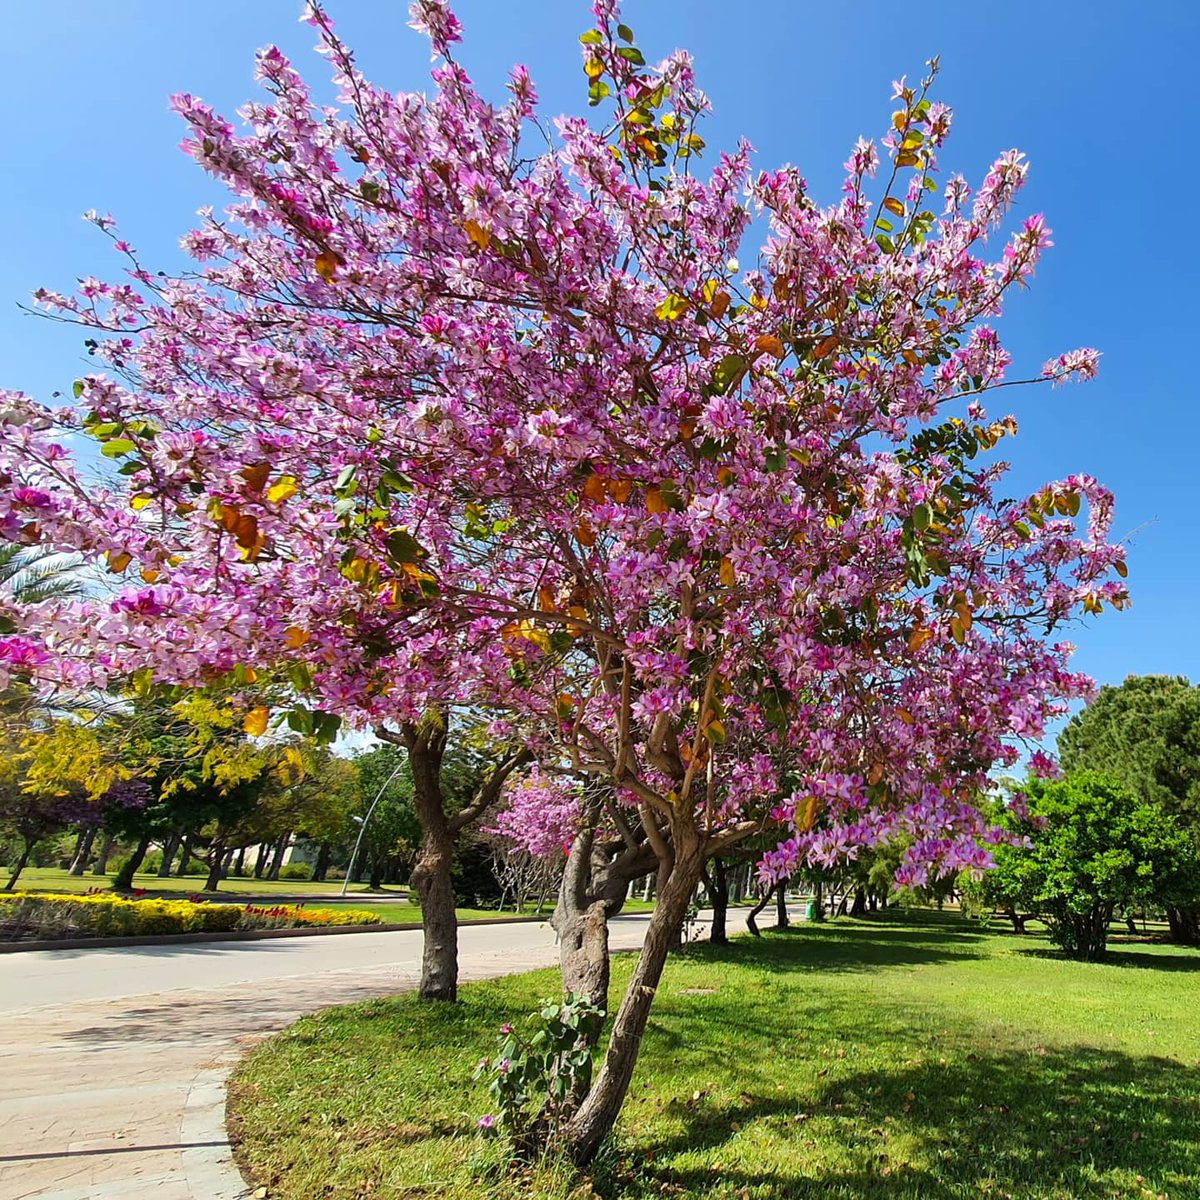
619 1049 1200 1200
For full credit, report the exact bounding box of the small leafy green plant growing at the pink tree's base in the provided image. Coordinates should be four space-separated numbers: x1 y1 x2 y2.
475 992 605 1146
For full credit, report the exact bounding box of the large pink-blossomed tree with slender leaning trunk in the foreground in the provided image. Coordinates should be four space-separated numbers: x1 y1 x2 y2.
0 0 1126 1159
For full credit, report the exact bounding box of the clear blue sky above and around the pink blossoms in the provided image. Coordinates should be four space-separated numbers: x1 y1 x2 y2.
0 0 1200 710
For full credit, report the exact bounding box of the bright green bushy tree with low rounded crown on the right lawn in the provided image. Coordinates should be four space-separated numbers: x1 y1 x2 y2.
980 772 1198 961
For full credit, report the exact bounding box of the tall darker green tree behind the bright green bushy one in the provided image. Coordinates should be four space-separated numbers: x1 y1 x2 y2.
1058 676 1200 946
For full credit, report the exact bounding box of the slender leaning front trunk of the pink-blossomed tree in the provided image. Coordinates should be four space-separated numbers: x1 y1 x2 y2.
566 822 704 1165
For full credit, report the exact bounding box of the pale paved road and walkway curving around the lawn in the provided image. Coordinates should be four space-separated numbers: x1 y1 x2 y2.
0 916 648 1200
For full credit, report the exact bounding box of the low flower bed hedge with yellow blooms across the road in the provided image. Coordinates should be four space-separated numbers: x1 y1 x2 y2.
0 892 379 941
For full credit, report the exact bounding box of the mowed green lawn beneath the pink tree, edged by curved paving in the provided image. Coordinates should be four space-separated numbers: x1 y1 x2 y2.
229 914 1200 1200
